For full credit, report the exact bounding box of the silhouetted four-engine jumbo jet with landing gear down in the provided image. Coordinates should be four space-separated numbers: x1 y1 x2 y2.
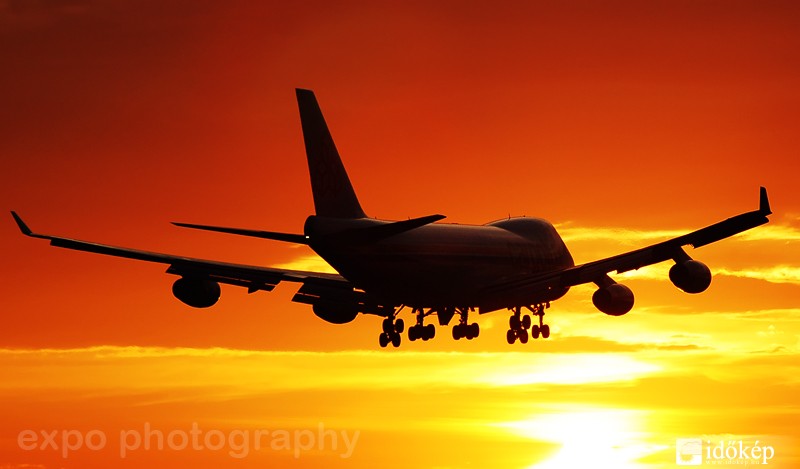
11 89 772 347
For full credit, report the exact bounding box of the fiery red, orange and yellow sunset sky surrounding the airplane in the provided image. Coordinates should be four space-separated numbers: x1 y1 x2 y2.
0 0 800 469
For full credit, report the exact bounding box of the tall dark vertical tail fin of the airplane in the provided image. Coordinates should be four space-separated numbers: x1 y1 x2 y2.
296 89 366 218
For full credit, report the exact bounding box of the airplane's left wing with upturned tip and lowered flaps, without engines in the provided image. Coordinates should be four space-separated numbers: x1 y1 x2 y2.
6 211 388 315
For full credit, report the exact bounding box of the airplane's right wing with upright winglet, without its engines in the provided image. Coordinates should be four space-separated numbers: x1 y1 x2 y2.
481 187 772 312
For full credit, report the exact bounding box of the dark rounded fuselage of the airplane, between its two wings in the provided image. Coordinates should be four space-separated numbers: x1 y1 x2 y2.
305 216 574 308
